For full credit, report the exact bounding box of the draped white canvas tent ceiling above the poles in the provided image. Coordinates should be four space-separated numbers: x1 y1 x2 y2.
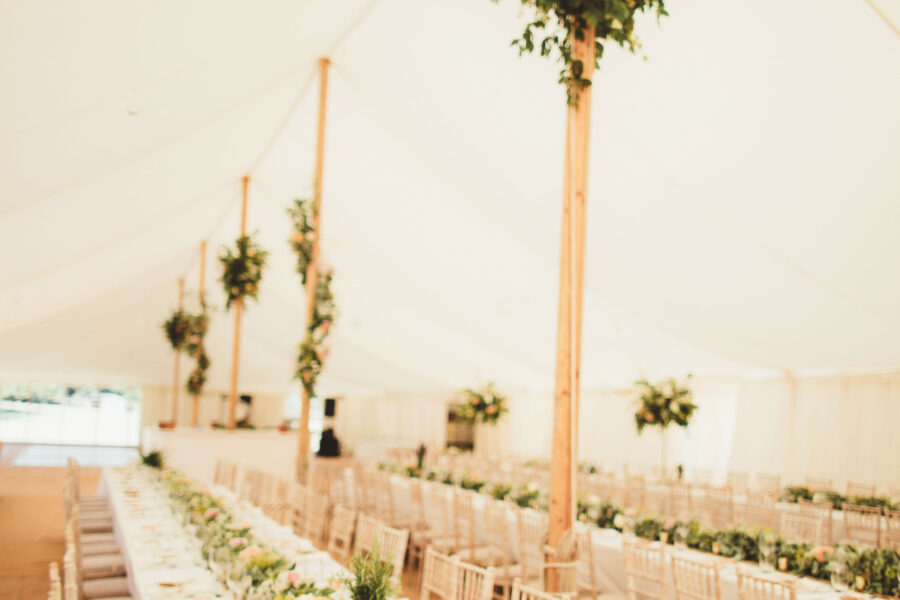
0 0 900 394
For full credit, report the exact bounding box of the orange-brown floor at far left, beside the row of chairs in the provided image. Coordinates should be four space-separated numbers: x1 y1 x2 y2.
0 464 100 600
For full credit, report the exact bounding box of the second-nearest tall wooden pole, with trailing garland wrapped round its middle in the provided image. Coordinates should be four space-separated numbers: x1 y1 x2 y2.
297 57 331 483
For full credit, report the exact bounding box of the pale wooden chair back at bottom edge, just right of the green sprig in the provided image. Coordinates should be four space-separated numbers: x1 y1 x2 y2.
421 547 494 600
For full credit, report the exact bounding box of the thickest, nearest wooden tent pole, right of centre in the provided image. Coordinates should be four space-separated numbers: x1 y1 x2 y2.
547 29 594 591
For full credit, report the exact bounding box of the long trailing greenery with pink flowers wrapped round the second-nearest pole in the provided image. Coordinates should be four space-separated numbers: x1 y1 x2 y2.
288 199 337 396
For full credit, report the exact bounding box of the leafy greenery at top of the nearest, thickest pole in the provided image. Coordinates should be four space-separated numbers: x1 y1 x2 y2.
493 0 668 105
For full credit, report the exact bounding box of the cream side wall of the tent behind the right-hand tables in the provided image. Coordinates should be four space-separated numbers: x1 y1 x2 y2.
496 374 900 493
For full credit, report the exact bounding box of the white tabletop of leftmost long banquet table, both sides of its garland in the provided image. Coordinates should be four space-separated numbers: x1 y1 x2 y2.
99 466 344 600
